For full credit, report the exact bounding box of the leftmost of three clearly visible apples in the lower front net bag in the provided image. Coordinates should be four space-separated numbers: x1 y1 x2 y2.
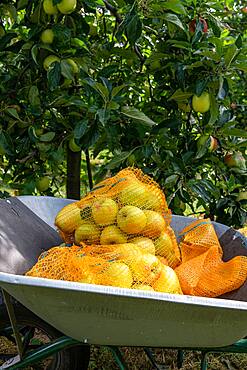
97 261 133 288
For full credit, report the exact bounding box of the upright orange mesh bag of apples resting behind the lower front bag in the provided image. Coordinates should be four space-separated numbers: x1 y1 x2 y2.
55 168 181 268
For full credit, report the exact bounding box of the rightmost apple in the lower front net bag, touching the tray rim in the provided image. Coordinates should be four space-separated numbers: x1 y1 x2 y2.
152 265 183 294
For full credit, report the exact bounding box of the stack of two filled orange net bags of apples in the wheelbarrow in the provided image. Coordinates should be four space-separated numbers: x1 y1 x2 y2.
27 168 182 294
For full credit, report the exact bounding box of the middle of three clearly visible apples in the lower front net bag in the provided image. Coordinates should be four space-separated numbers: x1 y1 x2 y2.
129 253 162 285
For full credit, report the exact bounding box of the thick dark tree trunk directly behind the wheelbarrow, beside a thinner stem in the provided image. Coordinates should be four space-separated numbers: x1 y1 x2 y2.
66 148 81 199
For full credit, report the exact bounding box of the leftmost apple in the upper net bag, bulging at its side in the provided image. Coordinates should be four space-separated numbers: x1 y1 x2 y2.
55 203 82 233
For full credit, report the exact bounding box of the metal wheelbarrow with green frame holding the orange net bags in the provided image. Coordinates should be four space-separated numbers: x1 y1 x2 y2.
0 196 247 370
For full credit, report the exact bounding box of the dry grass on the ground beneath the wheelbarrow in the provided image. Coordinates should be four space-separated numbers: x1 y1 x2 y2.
0 337 247 370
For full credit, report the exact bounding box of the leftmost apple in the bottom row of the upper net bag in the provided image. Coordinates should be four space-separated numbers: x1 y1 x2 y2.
75 221 100 245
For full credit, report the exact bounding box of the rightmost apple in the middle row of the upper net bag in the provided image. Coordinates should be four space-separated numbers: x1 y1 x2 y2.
142 210 166 238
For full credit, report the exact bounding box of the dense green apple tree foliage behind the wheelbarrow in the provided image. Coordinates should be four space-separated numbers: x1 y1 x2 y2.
0 0 247 227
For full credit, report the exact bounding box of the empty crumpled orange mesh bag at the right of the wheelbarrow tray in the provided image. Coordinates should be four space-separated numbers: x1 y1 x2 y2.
175 220 247 297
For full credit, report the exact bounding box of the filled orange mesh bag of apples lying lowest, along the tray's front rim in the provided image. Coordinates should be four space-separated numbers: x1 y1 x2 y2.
26 243 182 294
